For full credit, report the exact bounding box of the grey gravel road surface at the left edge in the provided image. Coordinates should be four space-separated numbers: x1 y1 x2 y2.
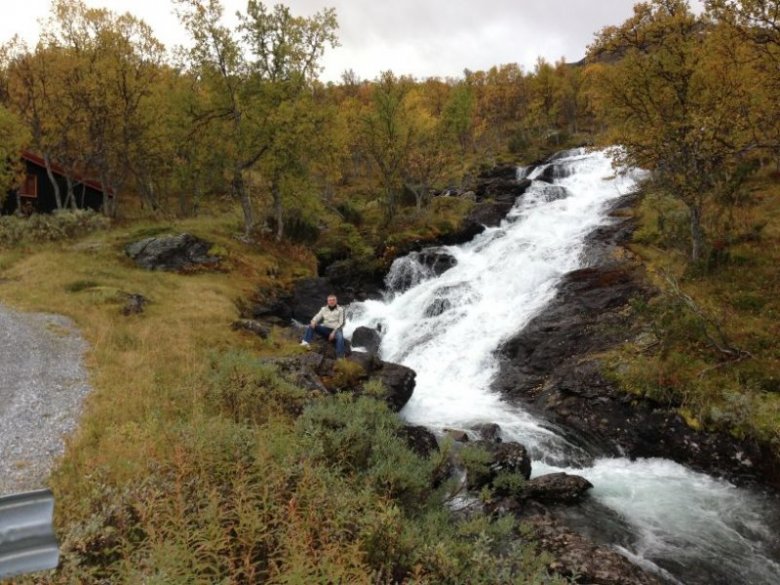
0 304 90 496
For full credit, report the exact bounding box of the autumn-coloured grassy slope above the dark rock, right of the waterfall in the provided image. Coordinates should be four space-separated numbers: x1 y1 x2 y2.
611 172 780 452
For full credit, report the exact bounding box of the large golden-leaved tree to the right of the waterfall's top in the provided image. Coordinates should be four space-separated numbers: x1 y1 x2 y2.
589 0 772 261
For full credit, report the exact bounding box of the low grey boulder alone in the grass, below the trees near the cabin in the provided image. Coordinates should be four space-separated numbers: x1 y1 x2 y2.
125 233 221 271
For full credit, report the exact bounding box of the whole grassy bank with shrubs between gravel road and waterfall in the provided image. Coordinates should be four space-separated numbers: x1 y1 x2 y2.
0 215 558 583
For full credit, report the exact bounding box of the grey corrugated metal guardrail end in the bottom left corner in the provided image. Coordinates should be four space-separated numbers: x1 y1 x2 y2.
0 490 60 580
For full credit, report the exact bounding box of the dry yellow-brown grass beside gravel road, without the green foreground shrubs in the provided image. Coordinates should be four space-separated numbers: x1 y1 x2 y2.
0 211 313 518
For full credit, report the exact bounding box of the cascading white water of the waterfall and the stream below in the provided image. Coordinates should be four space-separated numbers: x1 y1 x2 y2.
346 150 780 585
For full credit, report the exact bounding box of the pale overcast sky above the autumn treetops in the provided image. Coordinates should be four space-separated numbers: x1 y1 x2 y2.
0 0 699 81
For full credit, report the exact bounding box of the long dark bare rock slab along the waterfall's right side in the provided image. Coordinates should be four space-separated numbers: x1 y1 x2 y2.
496 198 780 486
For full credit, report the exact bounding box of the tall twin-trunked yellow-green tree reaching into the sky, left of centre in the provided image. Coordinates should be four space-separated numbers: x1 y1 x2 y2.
176 0 337 237
